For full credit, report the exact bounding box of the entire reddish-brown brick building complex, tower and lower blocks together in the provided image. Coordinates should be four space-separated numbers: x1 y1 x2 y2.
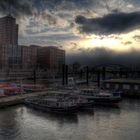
0 15 65 80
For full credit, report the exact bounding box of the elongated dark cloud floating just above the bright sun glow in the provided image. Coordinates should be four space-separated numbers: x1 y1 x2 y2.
75 12 140 34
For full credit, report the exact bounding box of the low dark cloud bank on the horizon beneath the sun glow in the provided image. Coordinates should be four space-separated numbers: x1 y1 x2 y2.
67 48 140 66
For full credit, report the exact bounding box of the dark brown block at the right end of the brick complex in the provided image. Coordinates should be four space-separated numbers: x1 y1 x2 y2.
38 46 65 72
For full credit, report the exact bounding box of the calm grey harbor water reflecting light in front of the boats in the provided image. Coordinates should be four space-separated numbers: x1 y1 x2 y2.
0 99 140 140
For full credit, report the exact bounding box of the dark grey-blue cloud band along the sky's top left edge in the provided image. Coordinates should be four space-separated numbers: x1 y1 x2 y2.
0 0 96 17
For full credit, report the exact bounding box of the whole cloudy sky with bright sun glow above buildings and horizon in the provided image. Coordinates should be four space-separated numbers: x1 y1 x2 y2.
0 0 140 65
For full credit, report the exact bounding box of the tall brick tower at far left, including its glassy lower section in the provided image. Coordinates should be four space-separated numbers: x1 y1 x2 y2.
0 15 21 71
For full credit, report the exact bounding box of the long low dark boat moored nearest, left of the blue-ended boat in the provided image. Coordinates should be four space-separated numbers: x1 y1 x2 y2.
25 97 78 113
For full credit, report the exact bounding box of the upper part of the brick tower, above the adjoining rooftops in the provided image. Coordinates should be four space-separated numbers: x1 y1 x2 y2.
0 15 18 45
